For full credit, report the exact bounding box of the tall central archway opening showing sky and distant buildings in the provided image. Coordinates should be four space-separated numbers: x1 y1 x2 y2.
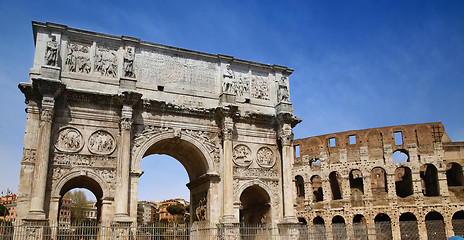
137 154 189 225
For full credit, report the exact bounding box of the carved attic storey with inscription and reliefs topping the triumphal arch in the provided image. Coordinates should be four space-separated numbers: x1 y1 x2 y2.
30 22 293 114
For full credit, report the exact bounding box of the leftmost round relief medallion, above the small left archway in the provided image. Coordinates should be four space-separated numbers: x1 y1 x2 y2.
55 127 84 152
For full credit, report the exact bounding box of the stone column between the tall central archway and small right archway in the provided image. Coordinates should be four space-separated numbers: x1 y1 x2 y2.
221 117 235 223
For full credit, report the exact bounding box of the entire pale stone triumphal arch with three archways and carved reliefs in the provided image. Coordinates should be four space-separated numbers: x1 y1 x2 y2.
17 22 300 237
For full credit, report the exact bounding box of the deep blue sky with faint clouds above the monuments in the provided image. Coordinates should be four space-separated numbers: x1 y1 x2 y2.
0 0 464 200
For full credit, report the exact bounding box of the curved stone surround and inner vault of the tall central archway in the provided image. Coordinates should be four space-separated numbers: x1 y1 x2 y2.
131 132 219 223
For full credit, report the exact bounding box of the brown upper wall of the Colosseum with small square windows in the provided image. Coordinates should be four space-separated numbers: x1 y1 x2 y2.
294 122 451 163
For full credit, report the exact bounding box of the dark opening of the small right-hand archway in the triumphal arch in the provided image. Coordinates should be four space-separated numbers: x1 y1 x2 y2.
240 185 271 224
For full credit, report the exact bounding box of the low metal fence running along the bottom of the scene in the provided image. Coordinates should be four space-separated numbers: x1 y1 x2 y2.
0 221 464 240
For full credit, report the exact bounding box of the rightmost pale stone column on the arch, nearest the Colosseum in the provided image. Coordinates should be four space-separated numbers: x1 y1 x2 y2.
279 123 297 222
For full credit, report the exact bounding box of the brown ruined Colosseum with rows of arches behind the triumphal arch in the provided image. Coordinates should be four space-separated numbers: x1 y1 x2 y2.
293 122 464 239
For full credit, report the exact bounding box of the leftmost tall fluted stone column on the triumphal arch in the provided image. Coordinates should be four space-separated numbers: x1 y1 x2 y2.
27 93 55 220
